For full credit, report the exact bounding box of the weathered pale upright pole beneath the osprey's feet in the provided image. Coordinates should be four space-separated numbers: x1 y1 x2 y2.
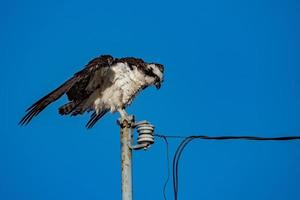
118 116 134 200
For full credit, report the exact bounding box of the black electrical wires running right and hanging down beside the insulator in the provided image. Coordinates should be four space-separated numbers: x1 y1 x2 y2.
154 134 300 200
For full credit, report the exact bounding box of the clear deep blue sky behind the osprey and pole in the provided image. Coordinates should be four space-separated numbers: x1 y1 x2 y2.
0 0 300 200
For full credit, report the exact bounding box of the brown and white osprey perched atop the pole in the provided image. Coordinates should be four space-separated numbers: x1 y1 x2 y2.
20 55 164 128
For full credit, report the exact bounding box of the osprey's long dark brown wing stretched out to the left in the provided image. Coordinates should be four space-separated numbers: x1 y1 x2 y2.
19 56 113 125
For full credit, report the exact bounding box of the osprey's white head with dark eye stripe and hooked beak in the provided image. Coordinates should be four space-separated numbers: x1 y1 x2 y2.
147 63 164 89
